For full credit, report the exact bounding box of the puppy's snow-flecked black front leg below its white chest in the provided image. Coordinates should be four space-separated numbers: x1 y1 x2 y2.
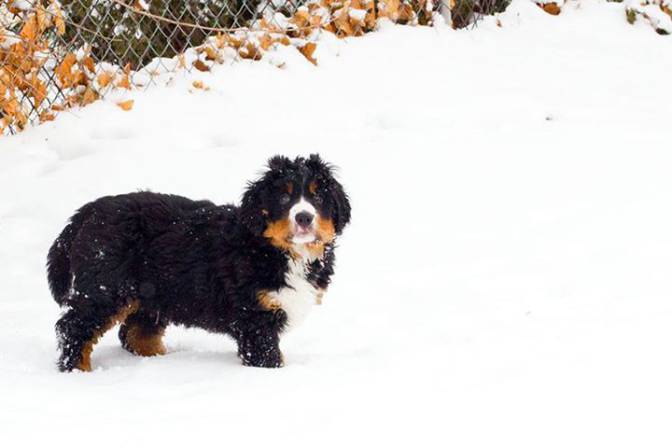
237 327 284 367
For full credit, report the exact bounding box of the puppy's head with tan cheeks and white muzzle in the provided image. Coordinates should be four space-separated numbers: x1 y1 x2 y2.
241 154 350 253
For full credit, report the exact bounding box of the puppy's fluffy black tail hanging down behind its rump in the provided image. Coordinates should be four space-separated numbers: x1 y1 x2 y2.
47 207 85 305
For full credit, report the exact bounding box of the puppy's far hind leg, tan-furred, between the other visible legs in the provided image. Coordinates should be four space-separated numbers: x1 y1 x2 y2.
119 308 166 356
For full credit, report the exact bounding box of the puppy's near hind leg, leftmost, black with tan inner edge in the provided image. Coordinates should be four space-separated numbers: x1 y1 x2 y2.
56 300 139 372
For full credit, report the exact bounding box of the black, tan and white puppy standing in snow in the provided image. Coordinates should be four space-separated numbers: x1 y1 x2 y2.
47 154 351 371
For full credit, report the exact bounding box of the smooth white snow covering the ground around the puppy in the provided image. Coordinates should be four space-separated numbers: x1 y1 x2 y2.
0 0 672 448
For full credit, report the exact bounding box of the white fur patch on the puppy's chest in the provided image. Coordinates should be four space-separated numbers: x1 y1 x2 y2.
271 259 318 331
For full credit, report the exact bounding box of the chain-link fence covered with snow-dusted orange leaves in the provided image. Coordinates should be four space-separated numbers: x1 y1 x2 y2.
0 0 509 134
